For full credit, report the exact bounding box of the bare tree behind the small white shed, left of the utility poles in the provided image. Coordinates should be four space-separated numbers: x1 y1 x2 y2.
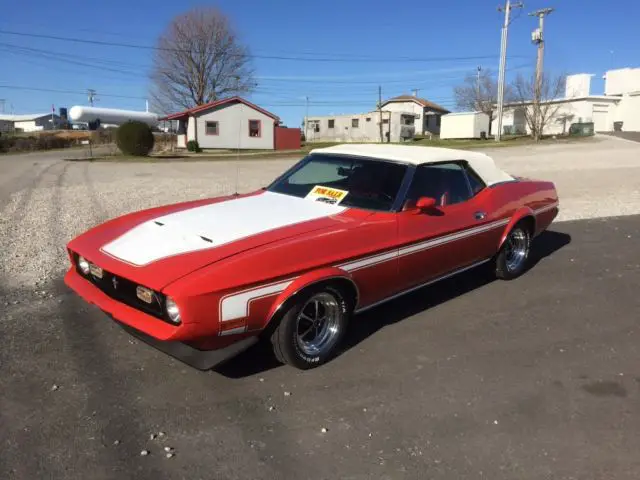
453 70 513 133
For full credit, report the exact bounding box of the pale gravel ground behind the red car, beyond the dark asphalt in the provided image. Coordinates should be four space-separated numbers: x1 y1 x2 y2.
0 137 640 288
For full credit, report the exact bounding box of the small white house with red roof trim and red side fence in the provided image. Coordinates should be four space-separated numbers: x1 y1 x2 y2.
160 97 300 150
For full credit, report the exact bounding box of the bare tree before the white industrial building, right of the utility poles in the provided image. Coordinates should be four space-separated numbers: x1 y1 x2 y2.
512 74 566 141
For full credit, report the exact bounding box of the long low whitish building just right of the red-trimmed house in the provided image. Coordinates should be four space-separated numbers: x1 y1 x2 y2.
304 111 415 143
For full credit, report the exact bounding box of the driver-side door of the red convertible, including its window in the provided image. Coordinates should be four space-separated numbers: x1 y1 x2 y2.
398 161 498 289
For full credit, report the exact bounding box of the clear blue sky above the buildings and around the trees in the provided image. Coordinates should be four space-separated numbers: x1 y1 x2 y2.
0 0 640 126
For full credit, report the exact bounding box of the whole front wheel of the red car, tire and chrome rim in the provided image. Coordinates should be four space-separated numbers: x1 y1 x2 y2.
271 286 350 370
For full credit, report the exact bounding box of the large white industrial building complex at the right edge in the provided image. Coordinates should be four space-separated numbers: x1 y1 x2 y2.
491 68 640 135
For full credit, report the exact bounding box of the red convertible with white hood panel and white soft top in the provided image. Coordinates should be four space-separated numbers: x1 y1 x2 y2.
65 144 558 369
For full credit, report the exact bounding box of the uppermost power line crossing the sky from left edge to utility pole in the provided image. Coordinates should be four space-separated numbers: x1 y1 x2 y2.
0 30 520 63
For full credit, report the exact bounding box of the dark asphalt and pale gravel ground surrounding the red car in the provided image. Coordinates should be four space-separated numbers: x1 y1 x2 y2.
0 138 640 480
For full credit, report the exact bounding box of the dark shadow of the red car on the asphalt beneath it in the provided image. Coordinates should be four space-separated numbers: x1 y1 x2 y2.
215 231 571 378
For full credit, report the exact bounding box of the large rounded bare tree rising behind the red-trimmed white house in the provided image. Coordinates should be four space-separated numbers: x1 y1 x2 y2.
151 7 255 113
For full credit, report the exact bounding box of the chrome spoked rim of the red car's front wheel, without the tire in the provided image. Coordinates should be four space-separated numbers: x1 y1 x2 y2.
296 292 342 356
